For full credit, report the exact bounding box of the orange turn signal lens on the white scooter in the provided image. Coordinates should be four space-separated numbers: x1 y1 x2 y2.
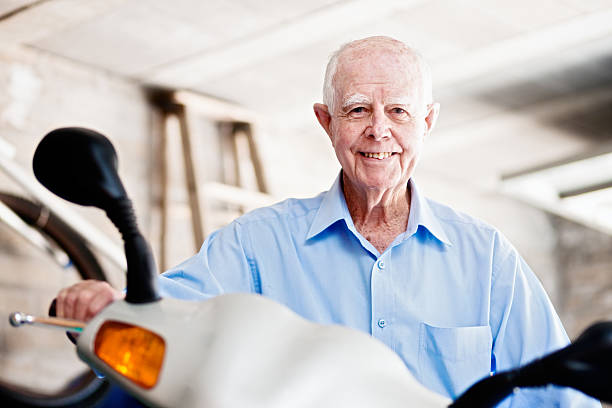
94 321 166 388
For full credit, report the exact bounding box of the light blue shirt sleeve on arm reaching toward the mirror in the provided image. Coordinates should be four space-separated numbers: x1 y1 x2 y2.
159 221 259 300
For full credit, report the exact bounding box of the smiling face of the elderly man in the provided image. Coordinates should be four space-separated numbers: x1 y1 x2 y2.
326 48 437 191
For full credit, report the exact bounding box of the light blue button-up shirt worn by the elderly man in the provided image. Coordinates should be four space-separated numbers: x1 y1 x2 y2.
161 177 600 407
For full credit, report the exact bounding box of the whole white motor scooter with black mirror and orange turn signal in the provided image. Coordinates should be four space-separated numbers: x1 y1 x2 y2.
5 128 612 408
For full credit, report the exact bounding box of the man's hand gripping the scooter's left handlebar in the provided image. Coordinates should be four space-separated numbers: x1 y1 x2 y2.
56 280 124 322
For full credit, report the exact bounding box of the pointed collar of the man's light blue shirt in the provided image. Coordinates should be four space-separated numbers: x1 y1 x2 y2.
306 172 452 245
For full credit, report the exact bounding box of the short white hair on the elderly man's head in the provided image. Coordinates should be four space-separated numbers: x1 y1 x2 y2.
323 36 433 113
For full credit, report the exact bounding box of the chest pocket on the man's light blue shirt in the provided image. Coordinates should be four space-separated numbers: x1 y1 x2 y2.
419 323 493 398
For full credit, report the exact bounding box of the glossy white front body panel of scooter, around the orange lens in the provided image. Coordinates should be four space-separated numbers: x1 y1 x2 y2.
77 294 451 408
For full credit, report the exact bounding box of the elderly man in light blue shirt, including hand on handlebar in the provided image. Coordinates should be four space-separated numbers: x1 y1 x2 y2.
58 37 599 407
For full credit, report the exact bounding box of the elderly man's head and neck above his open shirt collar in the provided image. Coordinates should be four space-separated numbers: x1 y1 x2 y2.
314 38 439 253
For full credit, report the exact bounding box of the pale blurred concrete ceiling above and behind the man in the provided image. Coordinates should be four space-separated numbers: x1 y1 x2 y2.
0 0 612 231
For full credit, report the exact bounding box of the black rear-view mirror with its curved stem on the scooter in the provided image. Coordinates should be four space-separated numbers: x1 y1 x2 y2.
32 127 160 303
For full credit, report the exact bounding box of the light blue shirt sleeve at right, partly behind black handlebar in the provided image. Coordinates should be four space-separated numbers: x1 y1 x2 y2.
490 236 601 408
